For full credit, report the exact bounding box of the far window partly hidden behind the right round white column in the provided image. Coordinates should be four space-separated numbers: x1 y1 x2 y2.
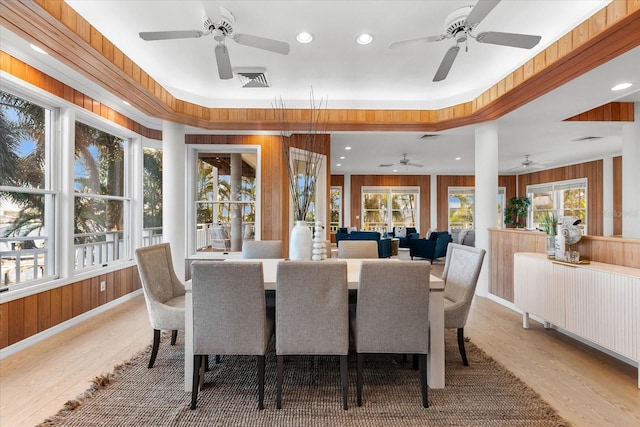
448 187 505 230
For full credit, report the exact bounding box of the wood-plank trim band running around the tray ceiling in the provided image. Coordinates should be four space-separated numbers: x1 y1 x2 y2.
1 0 640 132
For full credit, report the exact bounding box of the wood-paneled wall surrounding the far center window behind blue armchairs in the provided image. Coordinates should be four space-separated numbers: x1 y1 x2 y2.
350 175 431 232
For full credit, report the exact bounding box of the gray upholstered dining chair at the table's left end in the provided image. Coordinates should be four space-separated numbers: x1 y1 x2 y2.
135 243 185 368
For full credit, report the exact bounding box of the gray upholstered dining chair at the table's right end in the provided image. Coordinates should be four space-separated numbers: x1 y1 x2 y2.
442 243 486 366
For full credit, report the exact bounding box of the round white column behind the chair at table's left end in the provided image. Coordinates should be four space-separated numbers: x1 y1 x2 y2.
162 120 188 280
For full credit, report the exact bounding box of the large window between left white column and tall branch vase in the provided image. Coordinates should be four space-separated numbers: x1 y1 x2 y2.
196 152 257 251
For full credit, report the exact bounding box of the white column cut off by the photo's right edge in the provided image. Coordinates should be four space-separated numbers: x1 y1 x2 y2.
622 102 640 239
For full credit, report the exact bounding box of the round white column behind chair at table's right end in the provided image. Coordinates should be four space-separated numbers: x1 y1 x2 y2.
474 122 498 296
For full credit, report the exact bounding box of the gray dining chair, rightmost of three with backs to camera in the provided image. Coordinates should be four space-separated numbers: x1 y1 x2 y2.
353 261 431 408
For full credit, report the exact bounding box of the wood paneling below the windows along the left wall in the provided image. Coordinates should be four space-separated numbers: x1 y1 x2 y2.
0 266 141 348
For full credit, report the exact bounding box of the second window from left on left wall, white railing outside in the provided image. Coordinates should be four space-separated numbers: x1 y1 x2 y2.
74 122 130 269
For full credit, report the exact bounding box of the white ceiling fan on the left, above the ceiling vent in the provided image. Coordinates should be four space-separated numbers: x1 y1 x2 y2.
139 7 289 80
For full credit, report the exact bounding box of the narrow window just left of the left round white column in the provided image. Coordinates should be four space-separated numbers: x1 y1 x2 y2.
142 148 162 246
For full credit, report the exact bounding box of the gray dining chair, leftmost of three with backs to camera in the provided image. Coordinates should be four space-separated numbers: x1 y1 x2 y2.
191 261 274 410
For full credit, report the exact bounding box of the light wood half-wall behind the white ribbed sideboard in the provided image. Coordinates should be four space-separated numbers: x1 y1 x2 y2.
489 228 640 302
